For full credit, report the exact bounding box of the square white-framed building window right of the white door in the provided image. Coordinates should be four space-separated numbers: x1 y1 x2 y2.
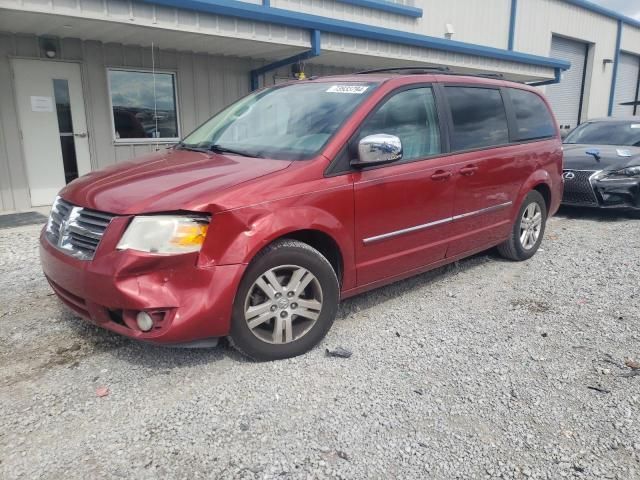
108 69 180 143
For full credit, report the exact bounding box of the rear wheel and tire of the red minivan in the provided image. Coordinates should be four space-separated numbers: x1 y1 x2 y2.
498 190 547 262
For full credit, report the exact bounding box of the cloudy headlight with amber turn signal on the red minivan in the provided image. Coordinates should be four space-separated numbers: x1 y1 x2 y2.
116 215 209 253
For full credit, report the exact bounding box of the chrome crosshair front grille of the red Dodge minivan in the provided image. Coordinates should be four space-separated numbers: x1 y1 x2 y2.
45 197 114 260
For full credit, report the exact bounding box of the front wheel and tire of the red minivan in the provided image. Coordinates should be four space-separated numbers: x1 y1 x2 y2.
229 239 340 361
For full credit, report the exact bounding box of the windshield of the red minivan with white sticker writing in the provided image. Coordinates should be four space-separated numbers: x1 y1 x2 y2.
180 82 375 160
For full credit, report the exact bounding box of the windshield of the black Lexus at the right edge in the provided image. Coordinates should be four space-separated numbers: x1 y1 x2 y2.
564 119 640 147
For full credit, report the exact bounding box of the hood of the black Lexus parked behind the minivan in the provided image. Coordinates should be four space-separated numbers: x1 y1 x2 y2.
563 143 640 170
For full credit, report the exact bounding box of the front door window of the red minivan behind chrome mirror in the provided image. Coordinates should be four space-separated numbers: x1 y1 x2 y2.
359 88 441 160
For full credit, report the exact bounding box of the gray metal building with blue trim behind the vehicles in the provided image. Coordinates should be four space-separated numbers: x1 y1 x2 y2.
0 0 640 211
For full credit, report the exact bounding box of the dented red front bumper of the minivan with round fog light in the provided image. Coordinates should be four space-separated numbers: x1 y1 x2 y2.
40 225 245 344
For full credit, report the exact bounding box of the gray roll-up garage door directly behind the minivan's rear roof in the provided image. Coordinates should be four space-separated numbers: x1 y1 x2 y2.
546 36 588 129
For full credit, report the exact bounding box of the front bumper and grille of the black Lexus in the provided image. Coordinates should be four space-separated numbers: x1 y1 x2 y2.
562 170 640 210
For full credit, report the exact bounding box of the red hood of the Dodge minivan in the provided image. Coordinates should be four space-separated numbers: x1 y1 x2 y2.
60 149 291 214
